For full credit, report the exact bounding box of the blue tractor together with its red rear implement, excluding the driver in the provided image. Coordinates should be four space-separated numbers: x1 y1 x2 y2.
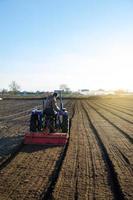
24 90 69 145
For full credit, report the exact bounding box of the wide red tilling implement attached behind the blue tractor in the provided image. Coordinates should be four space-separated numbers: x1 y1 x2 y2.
24 132 68 145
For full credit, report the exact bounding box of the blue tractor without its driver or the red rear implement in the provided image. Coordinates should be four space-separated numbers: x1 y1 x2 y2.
30 90 69 133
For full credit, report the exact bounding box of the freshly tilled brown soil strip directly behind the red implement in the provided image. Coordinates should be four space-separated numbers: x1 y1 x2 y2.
0 146 63 200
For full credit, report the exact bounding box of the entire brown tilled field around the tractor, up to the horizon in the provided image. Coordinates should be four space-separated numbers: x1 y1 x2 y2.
0 97 133 200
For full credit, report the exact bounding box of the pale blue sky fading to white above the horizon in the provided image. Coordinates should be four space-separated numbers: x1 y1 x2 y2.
0 0 133 91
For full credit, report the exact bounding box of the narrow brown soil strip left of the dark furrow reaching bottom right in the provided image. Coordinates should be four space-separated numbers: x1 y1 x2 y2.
79 102 114 199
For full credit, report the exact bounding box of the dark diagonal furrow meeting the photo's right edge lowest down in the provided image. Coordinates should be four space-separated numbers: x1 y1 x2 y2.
87 102 133 144
